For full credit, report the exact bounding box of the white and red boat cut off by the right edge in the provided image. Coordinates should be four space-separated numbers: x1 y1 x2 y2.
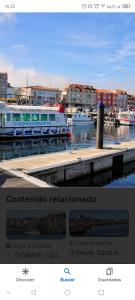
118 110 135 126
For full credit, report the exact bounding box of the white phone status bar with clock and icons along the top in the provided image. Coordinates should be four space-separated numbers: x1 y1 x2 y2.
0 0 135 13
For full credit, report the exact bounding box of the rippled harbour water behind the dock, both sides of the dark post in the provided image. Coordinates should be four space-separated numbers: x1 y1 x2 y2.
0 126 135 160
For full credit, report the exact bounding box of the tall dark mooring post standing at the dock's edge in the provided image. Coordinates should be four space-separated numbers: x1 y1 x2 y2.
96 102 104 149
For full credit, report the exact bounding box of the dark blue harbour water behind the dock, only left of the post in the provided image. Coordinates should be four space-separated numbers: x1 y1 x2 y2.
0 126 95 160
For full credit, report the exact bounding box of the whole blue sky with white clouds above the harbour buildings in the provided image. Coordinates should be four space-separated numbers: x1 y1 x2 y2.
0 13 135 94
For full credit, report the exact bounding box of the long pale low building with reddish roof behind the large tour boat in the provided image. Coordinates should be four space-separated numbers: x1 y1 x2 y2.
16 86 61 105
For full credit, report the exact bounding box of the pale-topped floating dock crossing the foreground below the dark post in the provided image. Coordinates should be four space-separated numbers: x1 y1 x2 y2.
0 141 135 187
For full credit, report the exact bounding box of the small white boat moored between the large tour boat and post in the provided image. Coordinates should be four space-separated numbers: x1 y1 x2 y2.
67 112 95 126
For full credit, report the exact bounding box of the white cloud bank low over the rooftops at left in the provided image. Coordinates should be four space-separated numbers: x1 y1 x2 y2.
0 56 72 88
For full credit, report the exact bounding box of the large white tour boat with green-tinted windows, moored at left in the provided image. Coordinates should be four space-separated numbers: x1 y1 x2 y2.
0 102 70 138
